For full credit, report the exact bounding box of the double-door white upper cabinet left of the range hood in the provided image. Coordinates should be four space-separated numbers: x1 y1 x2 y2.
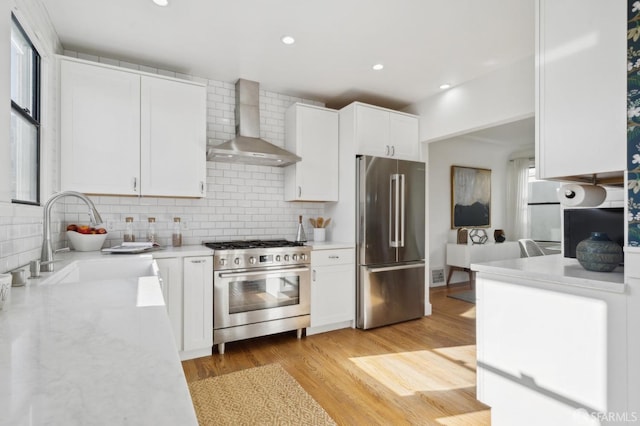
60 58 206 197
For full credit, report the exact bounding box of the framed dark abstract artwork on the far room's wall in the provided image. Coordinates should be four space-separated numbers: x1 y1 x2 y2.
451 166 491 229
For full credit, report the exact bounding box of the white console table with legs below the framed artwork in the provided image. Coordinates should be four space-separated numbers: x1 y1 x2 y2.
447 241 520 287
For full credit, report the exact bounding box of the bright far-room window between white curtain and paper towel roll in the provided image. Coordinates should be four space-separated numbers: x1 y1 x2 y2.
527 168 561 242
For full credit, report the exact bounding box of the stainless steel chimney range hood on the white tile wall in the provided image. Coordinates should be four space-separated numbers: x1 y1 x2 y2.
207 79 302 167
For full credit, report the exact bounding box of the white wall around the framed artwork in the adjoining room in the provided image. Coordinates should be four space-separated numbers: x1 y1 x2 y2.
427 137 514 283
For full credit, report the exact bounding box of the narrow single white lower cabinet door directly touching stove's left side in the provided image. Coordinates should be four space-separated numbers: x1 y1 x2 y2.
183 256 213 354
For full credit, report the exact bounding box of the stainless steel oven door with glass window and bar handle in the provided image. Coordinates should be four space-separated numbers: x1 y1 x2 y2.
213 266 311 329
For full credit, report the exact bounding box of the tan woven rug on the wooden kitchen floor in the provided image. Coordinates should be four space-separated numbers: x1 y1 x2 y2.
189 364 336 426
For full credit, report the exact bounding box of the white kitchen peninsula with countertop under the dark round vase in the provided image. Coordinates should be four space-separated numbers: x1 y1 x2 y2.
471 255 632 425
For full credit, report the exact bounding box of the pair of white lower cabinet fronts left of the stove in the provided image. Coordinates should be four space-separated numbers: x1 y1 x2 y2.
155 256 213 361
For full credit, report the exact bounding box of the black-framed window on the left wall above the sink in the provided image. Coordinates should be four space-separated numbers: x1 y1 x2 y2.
10 15 40 204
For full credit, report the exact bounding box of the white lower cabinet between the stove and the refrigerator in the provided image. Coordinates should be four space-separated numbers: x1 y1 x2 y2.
307 249 356 335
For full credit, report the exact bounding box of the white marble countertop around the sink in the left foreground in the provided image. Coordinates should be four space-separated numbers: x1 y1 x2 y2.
0 252 197 425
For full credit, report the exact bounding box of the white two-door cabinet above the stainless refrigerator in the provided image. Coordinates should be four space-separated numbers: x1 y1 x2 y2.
346 102 420 161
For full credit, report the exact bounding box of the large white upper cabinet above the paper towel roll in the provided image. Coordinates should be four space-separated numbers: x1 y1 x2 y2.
536 0 627 178
